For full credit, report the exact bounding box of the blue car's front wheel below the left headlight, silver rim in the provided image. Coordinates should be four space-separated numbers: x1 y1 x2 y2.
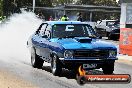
51 55 62 76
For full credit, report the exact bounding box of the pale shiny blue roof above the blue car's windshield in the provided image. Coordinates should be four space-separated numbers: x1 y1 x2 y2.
43 21 87 25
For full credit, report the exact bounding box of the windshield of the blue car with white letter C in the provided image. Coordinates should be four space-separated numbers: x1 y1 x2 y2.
53 24 95 38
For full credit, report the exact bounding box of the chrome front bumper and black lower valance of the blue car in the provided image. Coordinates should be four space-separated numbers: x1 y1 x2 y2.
59 58 118 69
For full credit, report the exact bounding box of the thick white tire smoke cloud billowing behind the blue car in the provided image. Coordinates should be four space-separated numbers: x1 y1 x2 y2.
0 11 42 61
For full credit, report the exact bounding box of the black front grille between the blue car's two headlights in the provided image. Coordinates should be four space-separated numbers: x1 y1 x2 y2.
74 50 109 58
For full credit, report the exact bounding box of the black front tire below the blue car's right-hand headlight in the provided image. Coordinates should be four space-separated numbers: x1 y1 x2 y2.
102 63 114 74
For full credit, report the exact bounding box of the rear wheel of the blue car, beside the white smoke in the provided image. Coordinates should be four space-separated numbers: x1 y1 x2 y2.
31 48 44 69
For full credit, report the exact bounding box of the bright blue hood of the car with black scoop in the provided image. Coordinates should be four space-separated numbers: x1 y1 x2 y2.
51 37 116 49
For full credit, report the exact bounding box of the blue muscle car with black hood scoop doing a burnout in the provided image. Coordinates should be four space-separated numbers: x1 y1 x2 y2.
27 21 117 76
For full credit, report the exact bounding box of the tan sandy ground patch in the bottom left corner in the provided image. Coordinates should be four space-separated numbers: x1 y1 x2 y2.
0 69 38 88
